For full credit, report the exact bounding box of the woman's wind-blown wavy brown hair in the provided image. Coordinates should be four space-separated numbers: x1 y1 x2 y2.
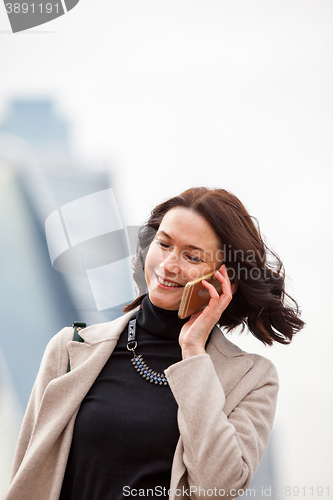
124 187 304 345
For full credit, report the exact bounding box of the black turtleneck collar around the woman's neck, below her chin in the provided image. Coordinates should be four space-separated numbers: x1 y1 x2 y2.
136 295 189 340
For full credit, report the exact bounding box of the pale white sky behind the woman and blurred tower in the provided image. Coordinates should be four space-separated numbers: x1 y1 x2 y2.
0 0 333 498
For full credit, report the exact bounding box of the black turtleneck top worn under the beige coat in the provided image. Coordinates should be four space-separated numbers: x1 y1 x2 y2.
59 296 188 500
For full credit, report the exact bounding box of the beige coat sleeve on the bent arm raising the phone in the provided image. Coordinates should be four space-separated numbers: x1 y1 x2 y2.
166 354 278 500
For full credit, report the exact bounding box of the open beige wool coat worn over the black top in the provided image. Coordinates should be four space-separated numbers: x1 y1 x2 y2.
4 313 278 500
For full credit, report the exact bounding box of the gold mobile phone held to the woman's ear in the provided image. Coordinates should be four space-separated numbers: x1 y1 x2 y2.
178 271 222 319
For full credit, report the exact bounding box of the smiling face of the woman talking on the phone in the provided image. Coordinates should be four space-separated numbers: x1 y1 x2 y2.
145 208 222 310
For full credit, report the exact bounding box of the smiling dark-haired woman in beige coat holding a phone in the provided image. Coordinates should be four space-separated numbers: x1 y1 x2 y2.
4 188 304 500
